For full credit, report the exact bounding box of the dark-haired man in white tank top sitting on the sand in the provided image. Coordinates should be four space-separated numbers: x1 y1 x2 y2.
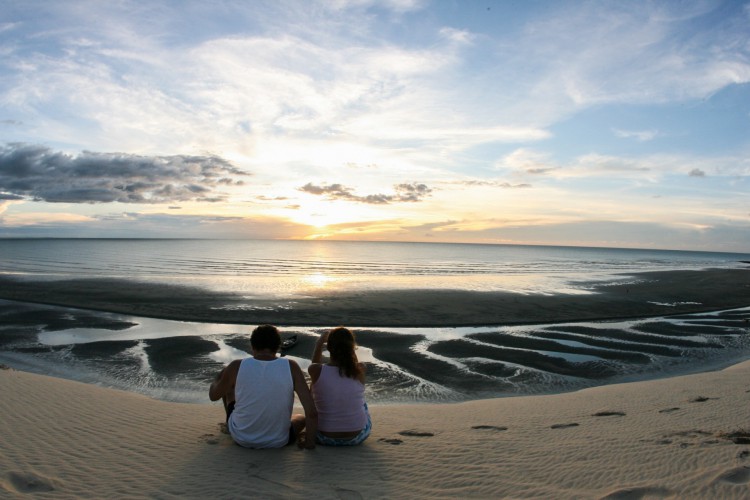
208 325 318 448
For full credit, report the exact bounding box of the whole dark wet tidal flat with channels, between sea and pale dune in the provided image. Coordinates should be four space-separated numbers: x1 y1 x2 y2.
0 269 750 404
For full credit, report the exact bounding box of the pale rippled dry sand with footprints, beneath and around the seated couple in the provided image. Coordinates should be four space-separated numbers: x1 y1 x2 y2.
0 361 750 499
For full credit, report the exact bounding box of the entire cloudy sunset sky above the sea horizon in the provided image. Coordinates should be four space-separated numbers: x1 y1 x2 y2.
0 0 750 252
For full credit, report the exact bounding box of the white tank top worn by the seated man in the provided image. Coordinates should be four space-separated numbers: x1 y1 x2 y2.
228 358 294 448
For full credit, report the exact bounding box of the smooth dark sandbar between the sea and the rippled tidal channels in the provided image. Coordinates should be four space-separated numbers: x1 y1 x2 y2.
0 268 750 328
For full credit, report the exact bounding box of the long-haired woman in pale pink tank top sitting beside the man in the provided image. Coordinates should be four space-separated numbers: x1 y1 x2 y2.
307 326 372 446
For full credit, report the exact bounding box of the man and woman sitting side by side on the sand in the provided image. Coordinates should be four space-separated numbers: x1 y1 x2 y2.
208 325 372 448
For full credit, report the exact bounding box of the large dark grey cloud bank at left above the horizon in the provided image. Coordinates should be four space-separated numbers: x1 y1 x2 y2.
0 143 247 203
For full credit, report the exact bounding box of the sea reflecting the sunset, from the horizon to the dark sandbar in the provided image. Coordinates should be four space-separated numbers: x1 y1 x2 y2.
0 239 750 298
